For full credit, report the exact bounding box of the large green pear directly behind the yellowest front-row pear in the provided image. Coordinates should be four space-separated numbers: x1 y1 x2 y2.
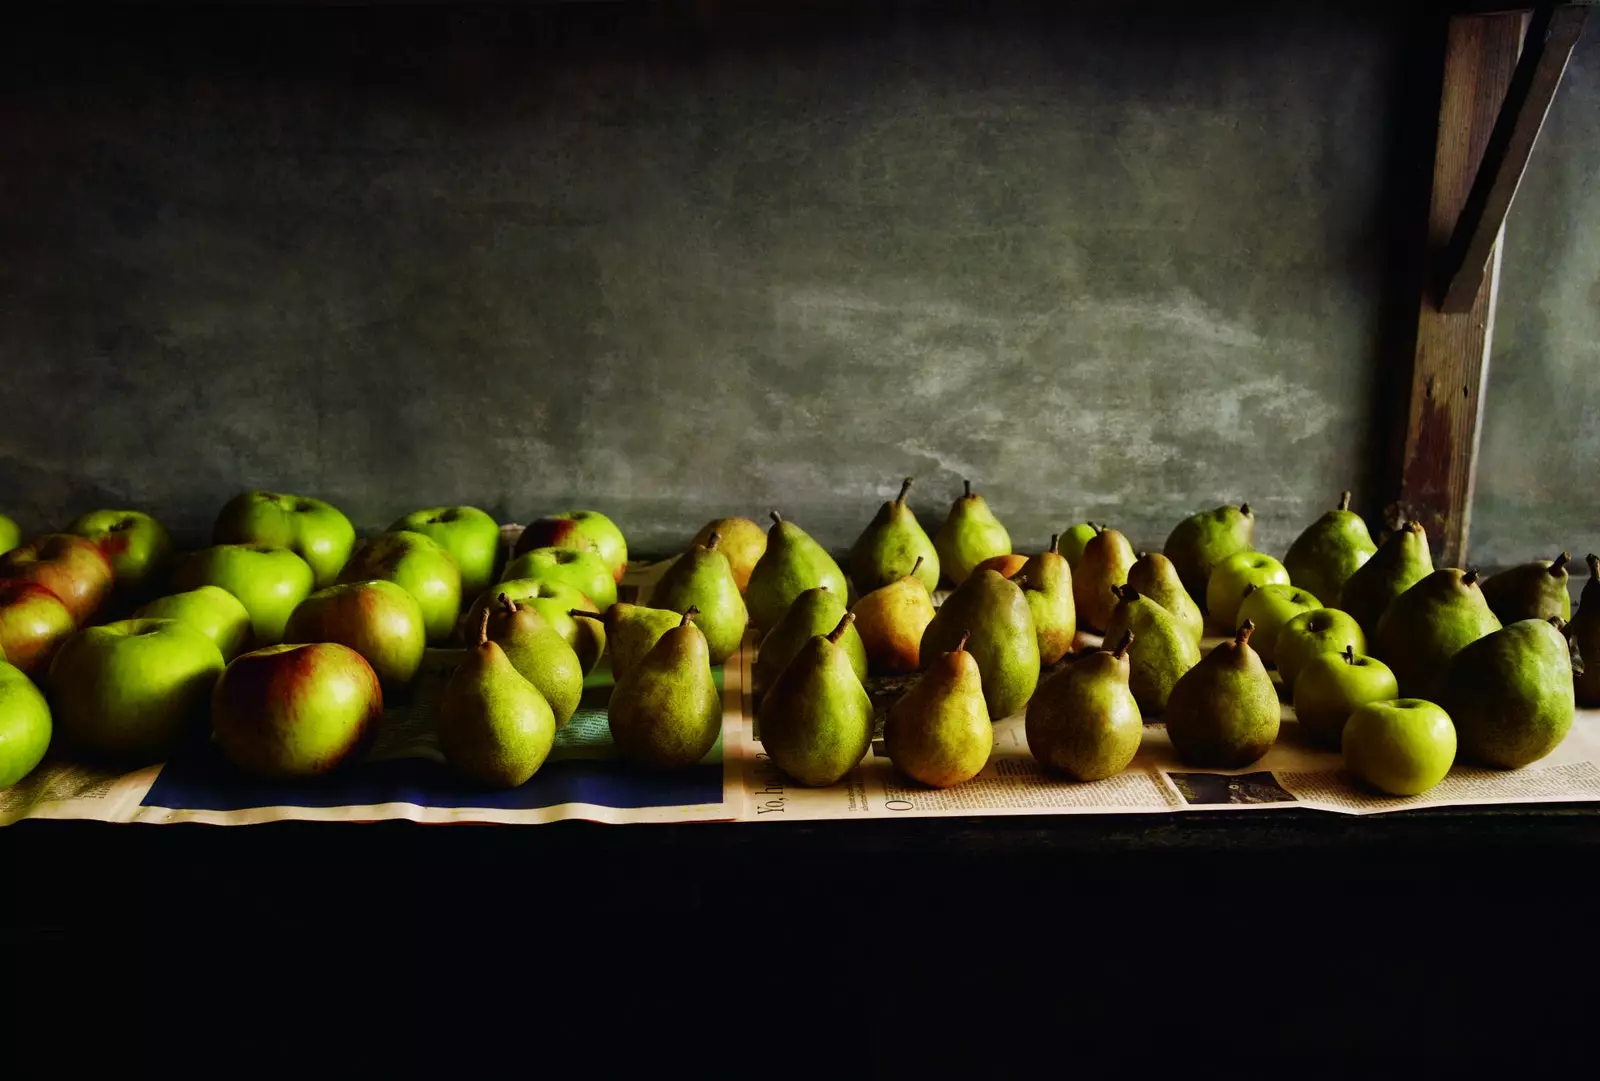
922 571 1038 721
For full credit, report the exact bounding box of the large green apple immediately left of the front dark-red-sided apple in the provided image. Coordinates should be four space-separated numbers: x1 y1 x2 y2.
50 619 224 760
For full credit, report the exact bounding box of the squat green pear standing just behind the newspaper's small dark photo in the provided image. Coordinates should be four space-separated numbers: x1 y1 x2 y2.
1166 620 1282 769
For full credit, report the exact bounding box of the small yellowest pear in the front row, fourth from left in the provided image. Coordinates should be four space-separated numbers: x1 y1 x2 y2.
883 638 995 788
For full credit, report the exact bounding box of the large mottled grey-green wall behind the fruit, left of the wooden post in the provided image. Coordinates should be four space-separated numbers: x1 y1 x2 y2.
0 13 1414 552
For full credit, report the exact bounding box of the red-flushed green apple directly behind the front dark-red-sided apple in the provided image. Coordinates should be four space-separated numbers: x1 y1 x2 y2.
283 580 427 691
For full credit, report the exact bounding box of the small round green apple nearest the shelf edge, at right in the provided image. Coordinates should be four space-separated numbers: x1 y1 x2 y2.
1342 699 1456 796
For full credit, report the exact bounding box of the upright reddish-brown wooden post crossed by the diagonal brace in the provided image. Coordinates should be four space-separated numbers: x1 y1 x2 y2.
1387 14 1523 566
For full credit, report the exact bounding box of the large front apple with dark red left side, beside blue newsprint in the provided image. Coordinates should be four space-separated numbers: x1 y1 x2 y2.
211 641 384 777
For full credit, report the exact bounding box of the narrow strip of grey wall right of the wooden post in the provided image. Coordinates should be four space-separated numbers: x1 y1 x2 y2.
1470 35 1600 564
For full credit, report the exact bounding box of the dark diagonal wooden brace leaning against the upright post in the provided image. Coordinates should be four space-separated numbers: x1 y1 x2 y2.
1437 5 1589 313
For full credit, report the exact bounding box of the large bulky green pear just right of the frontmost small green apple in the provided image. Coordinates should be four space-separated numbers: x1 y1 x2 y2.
1442 617 1573 769
